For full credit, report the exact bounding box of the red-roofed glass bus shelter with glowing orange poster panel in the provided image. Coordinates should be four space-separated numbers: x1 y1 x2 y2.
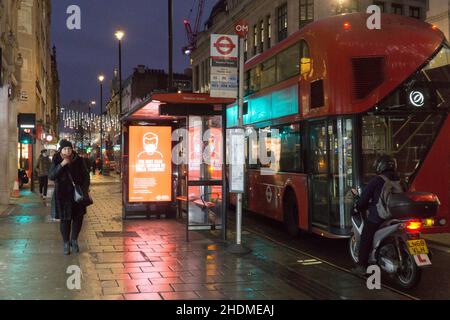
122 93 234 240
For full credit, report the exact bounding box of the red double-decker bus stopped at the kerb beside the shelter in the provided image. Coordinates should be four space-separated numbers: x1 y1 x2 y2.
227 13 450 237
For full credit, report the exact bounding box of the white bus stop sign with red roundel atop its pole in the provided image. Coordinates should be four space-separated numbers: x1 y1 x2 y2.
210 34 238 98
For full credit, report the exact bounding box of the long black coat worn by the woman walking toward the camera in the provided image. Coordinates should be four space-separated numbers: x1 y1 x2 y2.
49 152 90 220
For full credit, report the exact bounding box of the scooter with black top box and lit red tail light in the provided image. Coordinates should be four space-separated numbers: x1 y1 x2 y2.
349 189 440 289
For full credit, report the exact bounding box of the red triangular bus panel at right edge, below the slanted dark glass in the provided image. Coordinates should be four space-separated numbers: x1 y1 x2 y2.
411 117 450 233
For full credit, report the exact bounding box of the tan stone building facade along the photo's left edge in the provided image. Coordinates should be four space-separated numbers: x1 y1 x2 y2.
0 0 59 204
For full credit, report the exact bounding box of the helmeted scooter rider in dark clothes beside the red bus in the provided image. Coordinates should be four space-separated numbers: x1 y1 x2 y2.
352 155 400 275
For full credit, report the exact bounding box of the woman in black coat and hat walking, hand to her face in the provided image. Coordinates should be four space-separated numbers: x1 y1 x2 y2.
49 140 90 255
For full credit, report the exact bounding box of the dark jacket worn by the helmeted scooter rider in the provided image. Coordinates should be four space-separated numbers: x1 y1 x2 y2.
356 172 400 224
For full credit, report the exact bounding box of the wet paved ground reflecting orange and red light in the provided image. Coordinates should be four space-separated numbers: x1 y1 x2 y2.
0 178 414 300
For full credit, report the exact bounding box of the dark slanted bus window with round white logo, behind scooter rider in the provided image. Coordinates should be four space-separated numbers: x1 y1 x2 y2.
362 46 450 184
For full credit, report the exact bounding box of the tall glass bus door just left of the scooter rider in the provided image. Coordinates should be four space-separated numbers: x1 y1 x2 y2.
308 117 355 235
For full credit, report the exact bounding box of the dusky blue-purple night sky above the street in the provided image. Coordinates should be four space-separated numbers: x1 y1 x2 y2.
52 0 217 110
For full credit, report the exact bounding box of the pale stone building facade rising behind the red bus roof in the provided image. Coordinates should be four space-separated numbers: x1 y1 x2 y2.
191 0 428 92
